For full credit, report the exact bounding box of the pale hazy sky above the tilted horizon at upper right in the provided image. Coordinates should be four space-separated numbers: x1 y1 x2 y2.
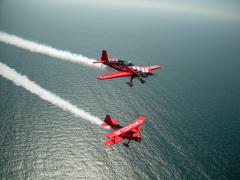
88 0 240 20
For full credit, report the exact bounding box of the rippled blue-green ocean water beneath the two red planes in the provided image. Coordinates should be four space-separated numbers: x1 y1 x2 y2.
0 0 240 179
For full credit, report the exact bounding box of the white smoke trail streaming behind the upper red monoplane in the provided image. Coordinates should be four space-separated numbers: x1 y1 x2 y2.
0 31 101 67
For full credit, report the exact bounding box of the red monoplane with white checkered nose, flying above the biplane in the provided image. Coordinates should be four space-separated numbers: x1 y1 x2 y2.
93 50 161 86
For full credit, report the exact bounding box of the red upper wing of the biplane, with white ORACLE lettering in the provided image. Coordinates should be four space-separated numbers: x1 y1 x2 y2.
104 116 146 138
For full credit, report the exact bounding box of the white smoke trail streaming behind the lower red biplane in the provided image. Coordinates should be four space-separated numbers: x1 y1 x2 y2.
0 62 102 125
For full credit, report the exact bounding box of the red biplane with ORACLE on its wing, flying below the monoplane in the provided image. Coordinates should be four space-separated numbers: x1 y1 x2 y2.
101 114 146 147
